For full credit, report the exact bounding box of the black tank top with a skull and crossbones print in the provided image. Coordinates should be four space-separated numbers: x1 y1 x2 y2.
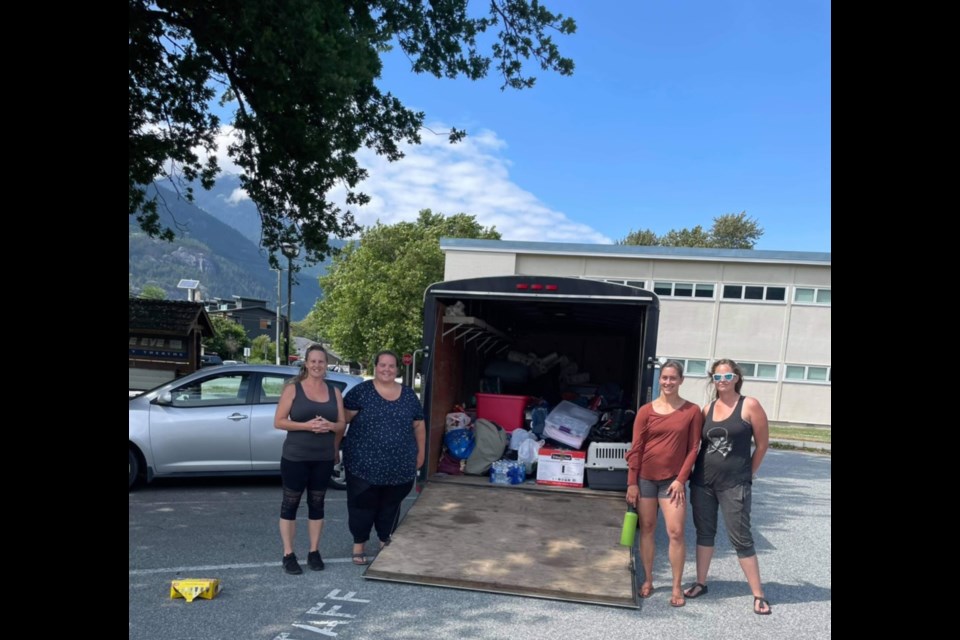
691 396 753 490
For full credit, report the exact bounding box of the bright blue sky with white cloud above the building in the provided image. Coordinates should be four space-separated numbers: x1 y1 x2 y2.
214 0 831 251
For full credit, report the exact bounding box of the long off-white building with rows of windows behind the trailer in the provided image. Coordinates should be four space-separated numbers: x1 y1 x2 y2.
440 238 832 425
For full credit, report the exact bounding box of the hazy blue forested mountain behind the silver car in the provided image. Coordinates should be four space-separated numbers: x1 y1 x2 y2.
129 186 329 320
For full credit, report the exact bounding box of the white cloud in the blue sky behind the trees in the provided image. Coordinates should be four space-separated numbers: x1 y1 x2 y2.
217 125 612 244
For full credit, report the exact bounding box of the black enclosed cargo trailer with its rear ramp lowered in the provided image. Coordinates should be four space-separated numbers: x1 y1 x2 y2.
364 276 659 607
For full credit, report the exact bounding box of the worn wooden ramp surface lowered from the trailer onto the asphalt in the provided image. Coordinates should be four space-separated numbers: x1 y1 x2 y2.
363 478 639 608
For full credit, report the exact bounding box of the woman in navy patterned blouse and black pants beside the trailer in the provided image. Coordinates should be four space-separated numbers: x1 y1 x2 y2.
343 351 426 564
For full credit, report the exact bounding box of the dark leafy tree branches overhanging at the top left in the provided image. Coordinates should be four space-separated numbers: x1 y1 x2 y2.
128 0 576 267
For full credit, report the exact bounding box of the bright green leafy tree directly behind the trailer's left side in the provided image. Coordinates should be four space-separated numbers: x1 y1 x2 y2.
307 209 500 364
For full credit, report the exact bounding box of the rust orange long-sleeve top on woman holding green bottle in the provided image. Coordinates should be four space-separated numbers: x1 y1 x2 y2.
627 401 703 484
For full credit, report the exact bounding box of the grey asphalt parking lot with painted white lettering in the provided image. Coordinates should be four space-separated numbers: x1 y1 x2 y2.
128 449 831 640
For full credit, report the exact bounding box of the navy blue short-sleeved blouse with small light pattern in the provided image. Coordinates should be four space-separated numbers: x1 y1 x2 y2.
343 380 423 485
